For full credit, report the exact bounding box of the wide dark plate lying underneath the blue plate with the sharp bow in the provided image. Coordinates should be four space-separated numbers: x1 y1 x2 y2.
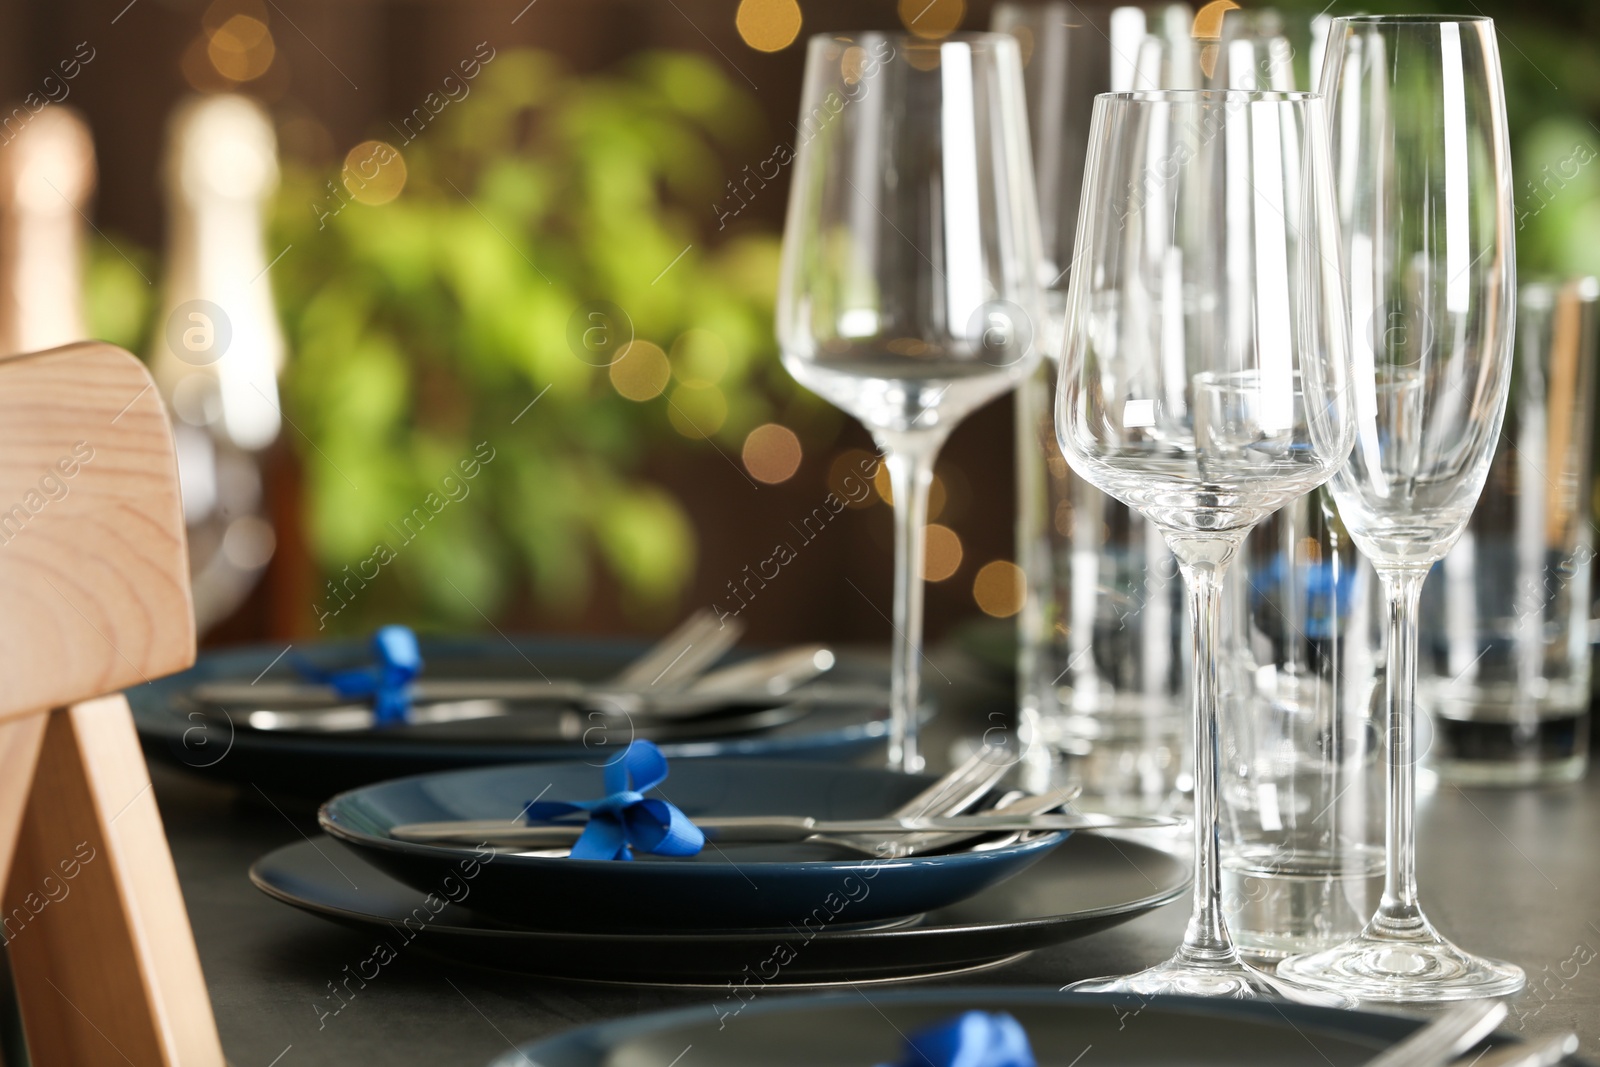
250 833 1189 989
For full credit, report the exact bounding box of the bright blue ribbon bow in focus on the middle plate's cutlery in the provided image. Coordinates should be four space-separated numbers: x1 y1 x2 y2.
523 741 706 859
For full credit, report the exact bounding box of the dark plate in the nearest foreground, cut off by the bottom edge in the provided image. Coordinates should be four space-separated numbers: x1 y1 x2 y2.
490 987 1576 1067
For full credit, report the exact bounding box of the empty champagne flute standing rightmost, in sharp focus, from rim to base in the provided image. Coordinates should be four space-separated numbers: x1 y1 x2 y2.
1278 16 1523 1000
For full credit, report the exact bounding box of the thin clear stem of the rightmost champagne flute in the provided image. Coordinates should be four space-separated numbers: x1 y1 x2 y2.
1368 568 1427 936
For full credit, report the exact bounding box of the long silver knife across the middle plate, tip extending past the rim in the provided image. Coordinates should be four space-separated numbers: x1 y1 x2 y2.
389 813 1178 846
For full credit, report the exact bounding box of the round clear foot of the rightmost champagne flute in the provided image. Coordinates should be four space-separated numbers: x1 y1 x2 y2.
1277 920 1528 1003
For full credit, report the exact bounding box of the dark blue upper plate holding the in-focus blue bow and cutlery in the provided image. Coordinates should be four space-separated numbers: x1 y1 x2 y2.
320 760 1066 931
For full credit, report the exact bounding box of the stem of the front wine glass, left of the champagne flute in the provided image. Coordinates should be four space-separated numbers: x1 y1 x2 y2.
1173 536 1242 965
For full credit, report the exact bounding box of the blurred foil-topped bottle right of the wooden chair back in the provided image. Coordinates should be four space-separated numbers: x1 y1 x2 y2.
150 93 283 632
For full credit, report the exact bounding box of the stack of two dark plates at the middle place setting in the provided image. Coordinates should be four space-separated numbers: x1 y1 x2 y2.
251 760 1189 985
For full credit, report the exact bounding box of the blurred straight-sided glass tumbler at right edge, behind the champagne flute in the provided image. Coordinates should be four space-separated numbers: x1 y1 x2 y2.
1421 278 1600 785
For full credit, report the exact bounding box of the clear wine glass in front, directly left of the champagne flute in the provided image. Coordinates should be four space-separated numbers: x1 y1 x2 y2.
1056 90 1352 997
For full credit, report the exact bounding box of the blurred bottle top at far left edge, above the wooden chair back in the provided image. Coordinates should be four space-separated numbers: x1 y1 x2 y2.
0 106 94 355
